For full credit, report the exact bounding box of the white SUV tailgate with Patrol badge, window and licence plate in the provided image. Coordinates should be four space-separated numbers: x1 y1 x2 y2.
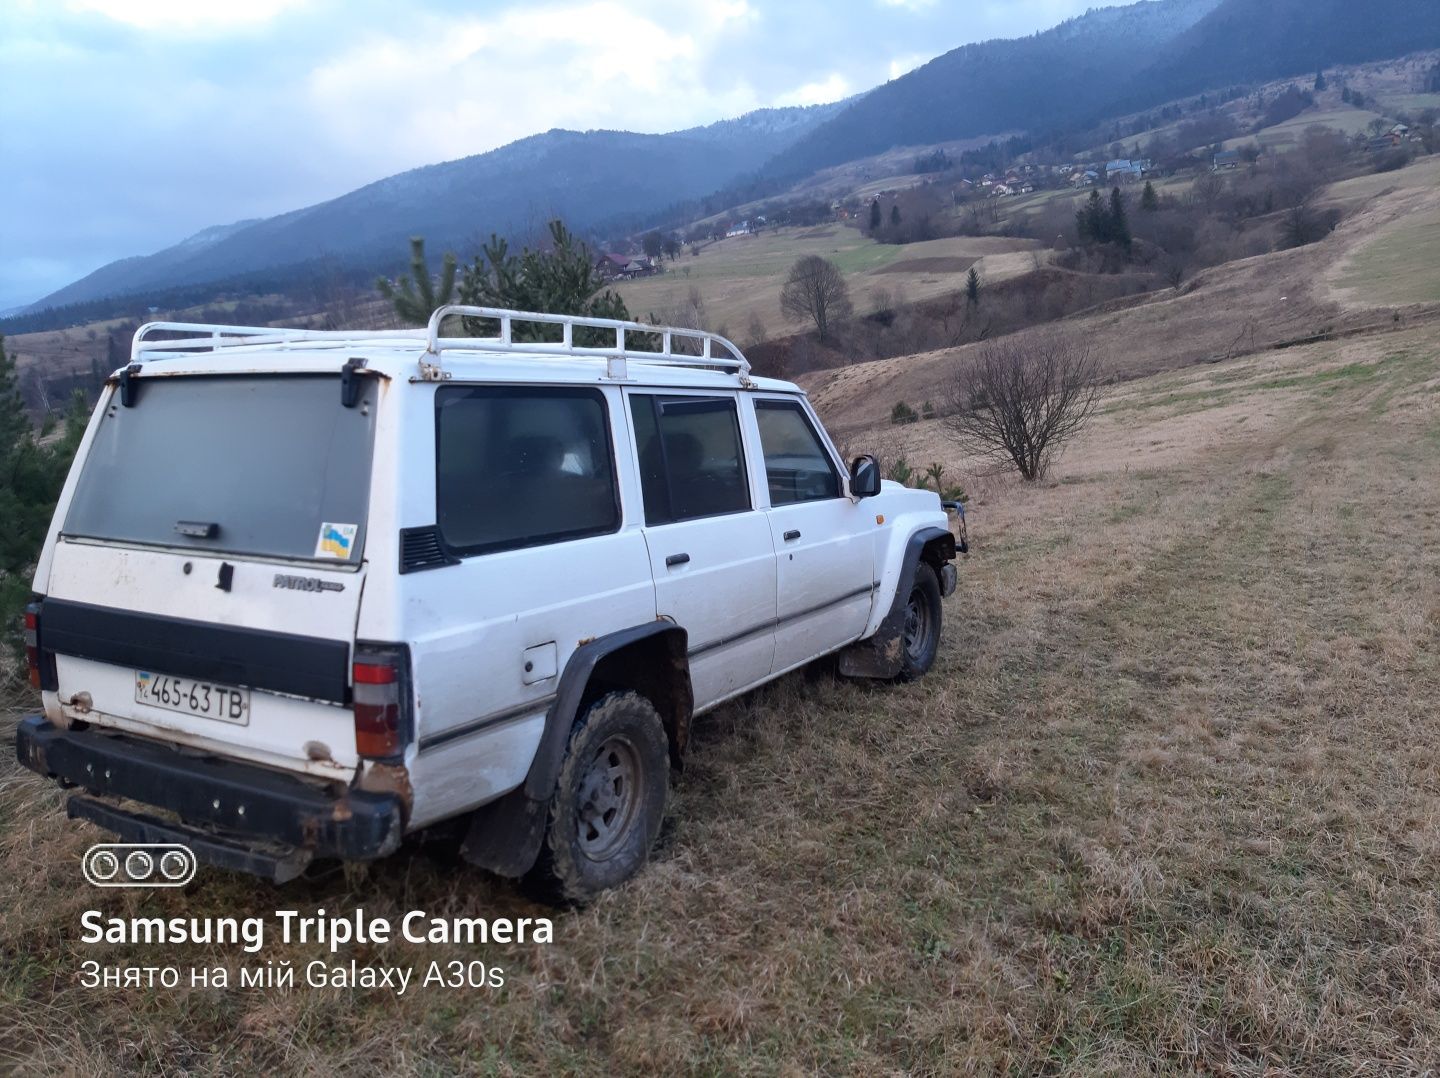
42 374 379 777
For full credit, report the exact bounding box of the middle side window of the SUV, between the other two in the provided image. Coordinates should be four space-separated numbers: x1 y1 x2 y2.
631 394 750 524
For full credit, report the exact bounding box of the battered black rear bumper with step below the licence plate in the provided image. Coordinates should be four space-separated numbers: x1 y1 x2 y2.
14 715 405 878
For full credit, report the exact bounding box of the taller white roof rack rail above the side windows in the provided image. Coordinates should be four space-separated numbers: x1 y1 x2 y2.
420 304 750 383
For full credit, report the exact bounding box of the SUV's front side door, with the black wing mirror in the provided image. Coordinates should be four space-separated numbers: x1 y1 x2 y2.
747 397 877 672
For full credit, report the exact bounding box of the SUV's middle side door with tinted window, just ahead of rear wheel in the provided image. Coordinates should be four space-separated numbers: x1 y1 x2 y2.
629 391 775 710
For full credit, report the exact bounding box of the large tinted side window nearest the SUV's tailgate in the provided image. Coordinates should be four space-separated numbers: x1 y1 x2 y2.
435 386 621 554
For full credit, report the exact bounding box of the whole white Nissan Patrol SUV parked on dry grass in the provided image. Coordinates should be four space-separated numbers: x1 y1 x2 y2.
17 307 956 901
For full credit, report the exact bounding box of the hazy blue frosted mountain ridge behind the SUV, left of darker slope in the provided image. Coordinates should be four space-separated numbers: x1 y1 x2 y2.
24 102 845 311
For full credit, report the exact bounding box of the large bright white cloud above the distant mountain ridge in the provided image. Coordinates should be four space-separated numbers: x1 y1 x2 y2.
302 0 765 168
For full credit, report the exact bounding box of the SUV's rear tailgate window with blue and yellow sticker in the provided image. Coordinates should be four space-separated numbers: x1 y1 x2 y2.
63 374 374 563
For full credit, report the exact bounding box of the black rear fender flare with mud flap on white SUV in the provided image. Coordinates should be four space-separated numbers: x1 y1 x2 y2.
461 620 693 877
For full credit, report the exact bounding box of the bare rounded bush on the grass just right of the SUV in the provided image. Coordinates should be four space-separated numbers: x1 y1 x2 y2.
946 334 1100 481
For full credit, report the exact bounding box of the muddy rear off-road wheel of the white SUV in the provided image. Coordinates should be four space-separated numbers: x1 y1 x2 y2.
526 692 670 905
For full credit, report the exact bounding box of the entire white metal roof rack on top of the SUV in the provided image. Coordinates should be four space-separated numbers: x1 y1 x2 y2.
130 305 750 383
